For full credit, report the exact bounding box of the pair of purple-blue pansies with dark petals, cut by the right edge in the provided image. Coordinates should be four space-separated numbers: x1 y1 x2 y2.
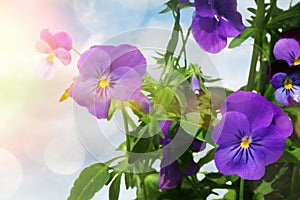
271 29 300 106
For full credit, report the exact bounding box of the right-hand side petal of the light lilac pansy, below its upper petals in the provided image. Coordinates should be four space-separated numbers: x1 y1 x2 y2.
109 67 142 101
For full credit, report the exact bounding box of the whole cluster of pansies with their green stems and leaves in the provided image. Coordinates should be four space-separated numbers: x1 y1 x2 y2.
36 0 300 199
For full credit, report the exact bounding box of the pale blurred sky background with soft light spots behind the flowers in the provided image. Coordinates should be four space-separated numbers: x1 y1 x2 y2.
0 0 296 200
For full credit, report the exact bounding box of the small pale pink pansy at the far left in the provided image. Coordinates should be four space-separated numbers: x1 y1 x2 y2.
36 29 72 80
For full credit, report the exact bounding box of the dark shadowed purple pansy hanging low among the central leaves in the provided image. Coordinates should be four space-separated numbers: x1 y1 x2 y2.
158 120 205 189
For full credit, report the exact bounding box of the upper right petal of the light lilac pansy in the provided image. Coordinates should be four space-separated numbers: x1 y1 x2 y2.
109 44 147 76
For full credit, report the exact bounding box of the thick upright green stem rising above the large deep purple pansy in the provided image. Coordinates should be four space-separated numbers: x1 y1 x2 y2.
246 0 265 92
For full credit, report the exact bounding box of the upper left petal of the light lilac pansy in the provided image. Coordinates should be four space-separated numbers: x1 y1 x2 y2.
77 47 111 80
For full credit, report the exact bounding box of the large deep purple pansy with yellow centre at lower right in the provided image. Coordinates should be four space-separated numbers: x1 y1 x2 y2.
213 91 293 180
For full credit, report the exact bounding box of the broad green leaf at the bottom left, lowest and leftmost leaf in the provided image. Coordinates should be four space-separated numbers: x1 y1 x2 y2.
68 163 110 200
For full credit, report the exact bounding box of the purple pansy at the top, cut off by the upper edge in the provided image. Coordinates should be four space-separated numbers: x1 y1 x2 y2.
192 0 245 53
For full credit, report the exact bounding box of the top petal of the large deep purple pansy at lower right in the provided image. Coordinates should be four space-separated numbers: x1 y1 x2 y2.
221 91 274 131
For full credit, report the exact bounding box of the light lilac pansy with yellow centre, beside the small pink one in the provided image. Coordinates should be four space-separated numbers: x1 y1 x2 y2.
69 44 147 119
